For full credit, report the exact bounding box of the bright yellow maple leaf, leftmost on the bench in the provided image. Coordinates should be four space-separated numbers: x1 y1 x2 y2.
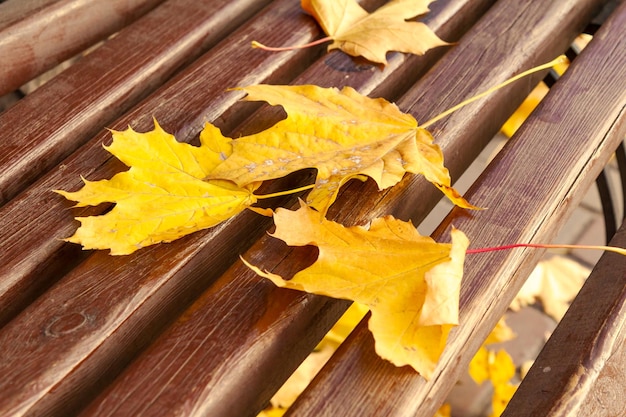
56 120 258 255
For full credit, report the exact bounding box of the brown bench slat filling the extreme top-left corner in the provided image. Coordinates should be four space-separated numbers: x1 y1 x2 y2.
0 0 163 95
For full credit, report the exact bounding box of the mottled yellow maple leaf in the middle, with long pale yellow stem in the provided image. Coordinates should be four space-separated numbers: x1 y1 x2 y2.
209 85 476 213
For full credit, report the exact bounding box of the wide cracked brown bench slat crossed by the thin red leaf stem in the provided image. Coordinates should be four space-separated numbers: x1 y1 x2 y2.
288 1 626 416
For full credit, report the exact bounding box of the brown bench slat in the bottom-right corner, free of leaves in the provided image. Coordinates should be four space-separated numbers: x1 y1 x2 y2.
502 221 626 417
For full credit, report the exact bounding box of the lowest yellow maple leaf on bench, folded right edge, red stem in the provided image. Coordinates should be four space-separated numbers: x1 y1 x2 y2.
244 204 469 378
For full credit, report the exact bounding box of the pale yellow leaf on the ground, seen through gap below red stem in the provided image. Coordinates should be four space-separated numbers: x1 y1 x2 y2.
510 256 591 321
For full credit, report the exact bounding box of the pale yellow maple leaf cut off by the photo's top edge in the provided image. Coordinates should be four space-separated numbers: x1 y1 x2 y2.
301 0 449 64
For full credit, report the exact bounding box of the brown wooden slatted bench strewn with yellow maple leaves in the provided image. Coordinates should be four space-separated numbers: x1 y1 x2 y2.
0 0 626 416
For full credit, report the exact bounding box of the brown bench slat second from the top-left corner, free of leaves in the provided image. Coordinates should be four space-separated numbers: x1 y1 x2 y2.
0 0 276 204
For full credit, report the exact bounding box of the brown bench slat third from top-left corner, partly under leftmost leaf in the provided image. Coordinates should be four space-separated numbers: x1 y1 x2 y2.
0 0 322 325
